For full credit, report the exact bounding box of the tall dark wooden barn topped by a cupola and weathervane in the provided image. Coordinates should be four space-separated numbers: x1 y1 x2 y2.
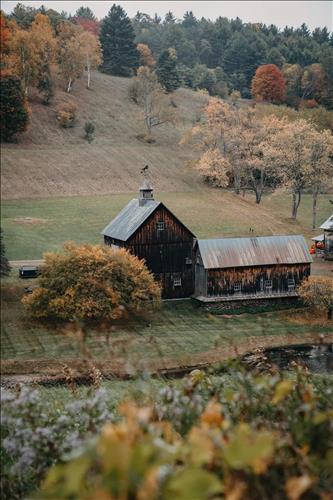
102 181 195 299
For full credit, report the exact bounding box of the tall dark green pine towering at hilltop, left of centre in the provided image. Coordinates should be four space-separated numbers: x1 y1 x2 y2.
100 4 139 76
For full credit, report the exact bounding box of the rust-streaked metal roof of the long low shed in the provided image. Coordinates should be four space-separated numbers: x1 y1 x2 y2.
198 235 312 269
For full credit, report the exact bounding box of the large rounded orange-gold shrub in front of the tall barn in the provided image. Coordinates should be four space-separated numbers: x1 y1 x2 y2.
22 243 160 321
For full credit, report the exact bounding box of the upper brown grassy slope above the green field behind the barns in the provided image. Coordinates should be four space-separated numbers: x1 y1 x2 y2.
1 72 207 198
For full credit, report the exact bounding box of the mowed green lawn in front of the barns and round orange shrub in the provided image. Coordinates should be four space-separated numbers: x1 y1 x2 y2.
1 278 331 363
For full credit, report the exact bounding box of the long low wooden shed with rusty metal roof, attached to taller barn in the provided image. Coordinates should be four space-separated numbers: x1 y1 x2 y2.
194 235 312 302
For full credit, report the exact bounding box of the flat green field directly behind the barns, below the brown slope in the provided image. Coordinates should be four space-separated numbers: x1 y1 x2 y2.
1 188 332 260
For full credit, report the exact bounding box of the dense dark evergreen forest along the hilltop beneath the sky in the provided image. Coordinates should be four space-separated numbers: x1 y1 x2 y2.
1 4 333 109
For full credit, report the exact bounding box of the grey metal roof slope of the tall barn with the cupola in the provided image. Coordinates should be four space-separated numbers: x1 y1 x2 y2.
101 199 160 241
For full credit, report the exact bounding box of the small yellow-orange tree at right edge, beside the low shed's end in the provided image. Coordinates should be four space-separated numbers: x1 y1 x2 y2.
299 276 333 319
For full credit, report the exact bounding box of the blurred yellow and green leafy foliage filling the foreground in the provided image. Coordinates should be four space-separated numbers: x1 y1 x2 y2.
3 364 333 500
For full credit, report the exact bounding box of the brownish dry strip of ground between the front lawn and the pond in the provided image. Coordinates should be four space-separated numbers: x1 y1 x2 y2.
1 333 333 385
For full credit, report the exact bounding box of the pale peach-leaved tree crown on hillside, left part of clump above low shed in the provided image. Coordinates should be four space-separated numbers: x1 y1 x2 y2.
185 98 283 204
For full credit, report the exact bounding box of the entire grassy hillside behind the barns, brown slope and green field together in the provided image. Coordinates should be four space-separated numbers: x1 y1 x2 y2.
1 72 332 260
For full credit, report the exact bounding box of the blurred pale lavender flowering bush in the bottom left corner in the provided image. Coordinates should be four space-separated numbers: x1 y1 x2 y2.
1 387 113 499
